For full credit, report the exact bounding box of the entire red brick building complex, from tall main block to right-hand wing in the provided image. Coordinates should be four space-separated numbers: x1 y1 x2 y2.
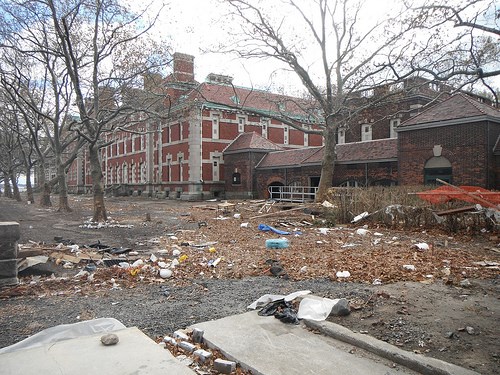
68 53 500 200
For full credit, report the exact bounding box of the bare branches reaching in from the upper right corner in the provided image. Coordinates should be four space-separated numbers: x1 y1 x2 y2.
405 0 500 103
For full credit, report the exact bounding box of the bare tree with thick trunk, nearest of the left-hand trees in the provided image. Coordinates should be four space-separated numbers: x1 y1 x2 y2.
40 0 168 221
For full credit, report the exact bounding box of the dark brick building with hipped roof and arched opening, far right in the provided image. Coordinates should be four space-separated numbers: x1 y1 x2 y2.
398 93 500 189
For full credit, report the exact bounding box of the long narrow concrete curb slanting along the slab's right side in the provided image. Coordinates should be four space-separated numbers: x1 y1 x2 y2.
303 319 480 375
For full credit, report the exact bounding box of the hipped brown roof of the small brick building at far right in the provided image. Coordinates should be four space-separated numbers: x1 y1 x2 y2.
400 93 500 128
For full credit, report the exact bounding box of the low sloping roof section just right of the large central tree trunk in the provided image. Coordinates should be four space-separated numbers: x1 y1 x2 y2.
336 138 398 163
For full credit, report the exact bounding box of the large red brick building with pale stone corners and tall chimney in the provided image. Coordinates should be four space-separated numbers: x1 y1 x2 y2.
69 53 322 200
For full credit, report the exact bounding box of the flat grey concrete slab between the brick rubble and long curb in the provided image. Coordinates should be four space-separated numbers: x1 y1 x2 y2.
193 311 418 375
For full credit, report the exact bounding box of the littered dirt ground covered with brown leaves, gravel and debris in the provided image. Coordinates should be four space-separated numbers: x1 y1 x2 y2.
0 196 500 374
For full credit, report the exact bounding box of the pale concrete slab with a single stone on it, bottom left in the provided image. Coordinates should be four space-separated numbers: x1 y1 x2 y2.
0 327 195 375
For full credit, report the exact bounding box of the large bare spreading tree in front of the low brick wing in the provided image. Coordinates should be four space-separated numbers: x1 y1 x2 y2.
225 0 418 201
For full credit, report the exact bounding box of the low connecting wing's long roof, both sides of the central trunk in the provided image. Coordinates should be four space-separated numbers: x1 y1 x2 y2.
257 138 398 168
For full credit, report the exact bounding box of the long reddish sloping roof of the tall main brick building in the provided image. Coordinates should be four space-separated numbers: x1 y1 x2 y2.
185 82 318 123
